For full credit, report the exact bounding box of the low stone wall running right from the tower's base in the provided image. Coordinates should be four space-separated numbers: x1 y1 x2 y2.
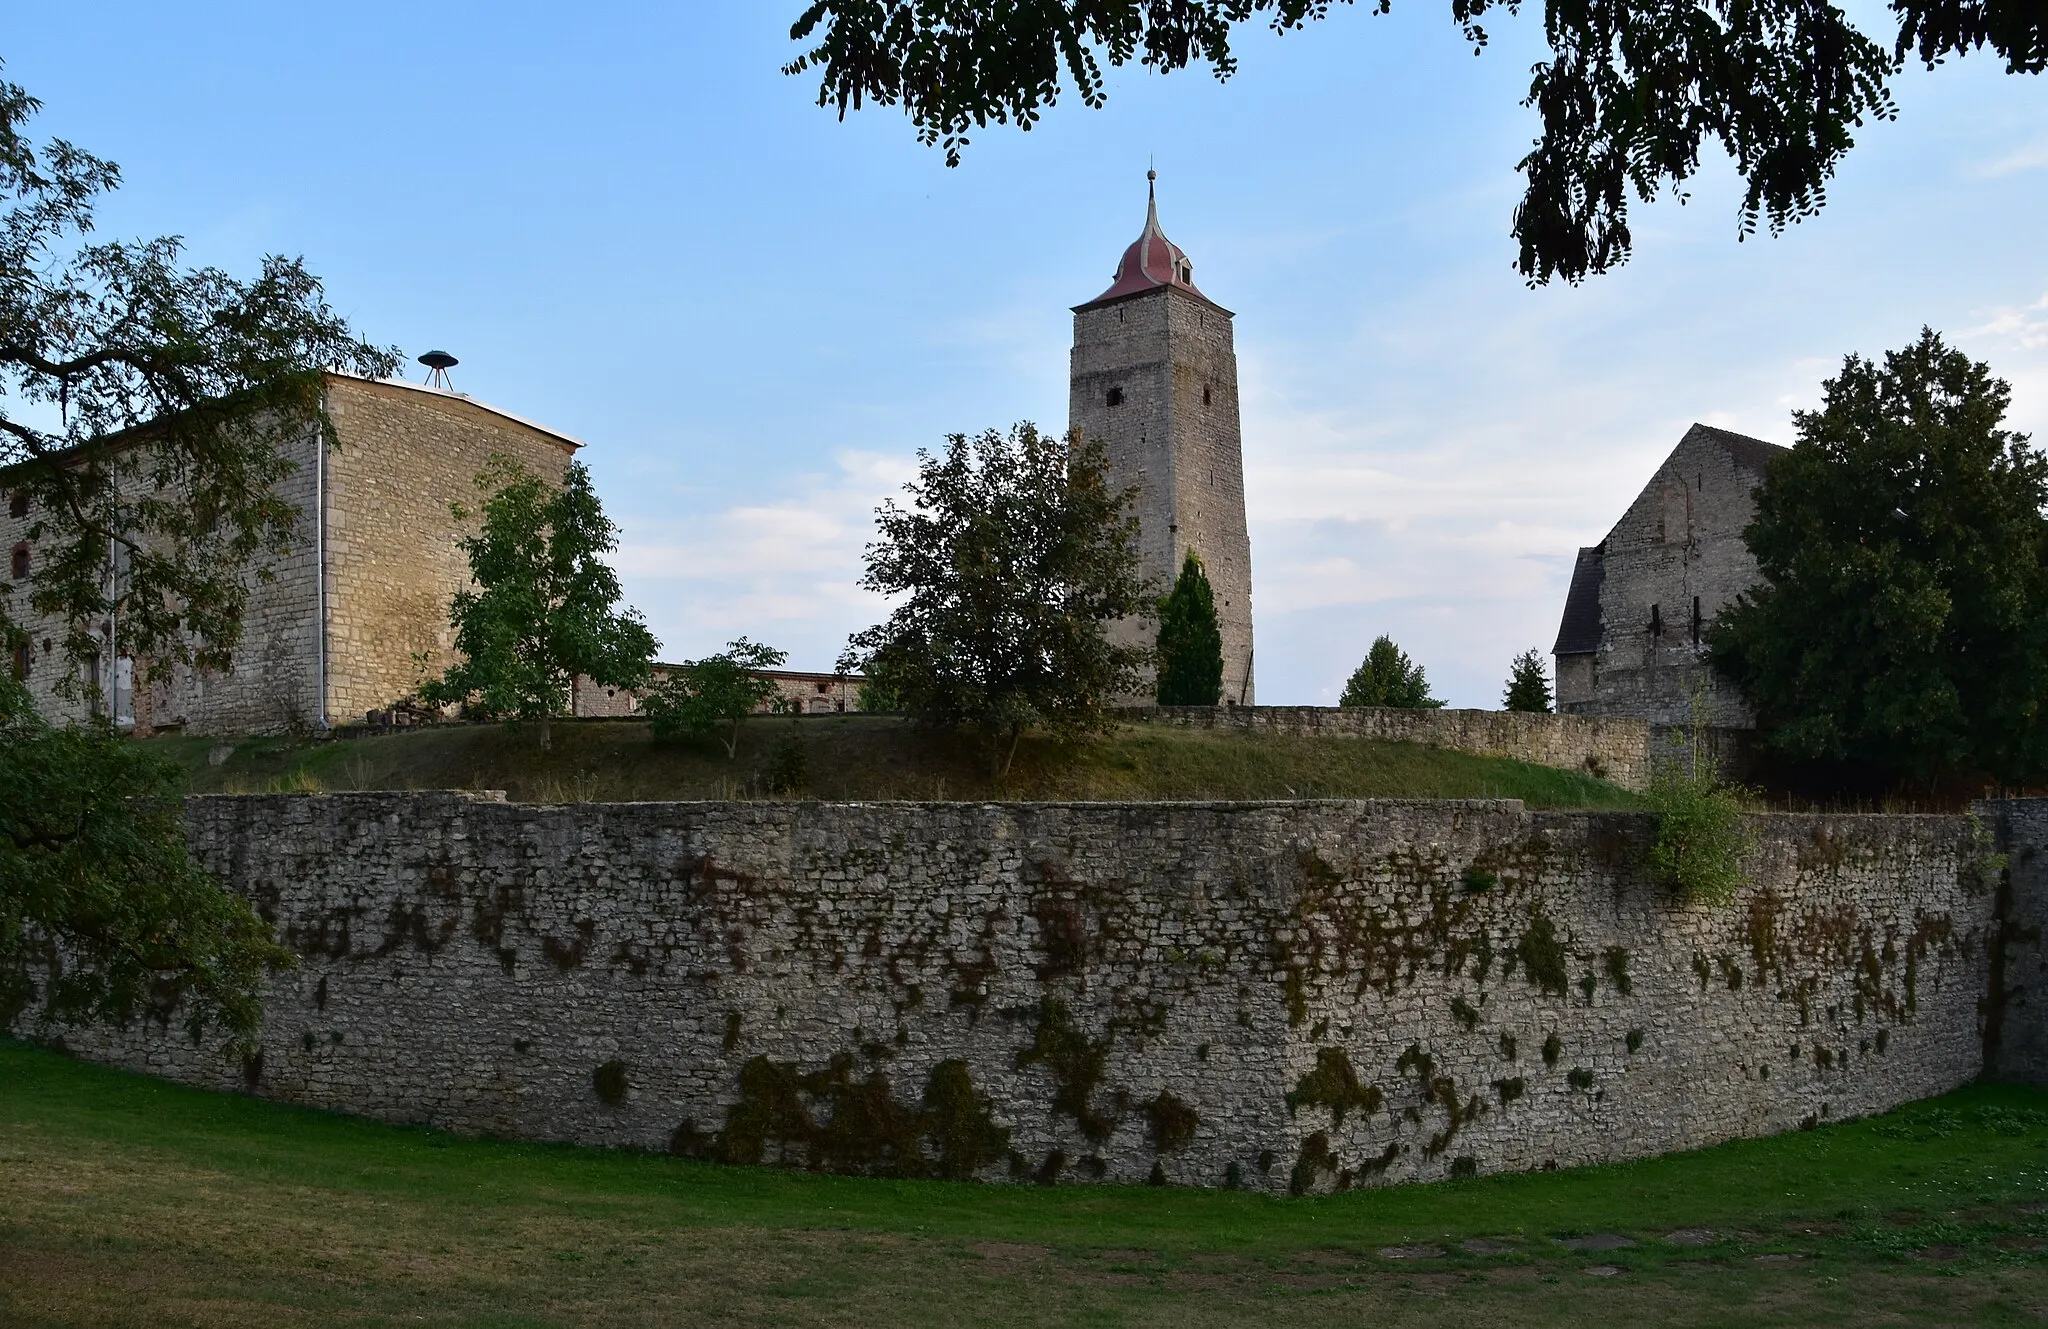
1124 706 1651 790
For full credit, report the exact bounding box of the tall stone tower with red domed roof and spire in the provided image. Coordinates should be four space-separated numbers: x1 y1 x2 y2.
1067 172 1253 706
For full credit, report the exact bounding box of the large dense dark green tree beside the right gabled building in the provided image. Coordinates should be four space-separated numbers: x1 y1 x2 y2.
1708 330 2048 784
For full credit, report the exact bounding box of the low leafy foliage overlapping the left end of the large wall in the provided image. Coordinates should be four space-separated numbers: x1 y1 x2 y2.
0 676 293 1046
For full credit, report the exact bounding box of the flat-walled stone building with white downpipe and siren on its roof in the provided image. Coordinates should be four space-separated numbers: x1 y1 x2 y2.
0 373 582 733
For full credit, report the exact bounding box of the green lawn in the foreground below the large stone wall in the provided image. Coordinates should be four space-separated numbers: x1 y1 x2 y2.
0 1042 2048 1329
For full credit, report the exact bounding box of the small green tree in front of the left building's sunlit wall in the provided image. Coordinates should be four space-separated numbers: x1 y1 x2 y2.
420 455 653 752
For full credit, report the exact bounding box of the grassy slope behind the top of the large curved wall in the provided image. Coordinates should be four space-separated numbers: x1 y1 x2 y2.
152 715 1640 807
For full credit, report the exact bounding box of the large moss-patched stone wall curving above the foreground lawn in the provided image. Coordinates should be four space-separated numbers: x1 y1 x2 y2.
31 792 2019 1190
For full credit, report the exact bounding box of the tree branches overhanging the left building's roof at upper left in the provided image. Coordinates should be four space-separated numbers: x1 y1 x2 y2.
0 68 397 694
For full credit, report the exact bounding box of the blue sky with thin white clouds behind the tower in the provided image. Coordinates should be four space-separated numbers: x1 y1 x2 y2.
16 0 2048 706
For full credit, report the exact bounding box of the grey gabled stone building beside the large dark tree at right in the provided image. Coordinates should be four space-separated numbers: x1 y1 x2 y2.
1552 424 1786 729
